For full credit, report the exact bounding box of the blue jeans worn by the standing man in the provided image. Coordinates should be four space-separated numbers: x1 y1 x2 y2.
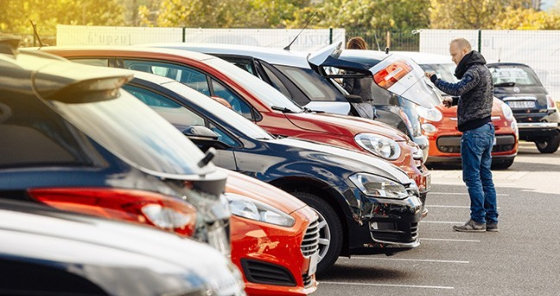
461 123 498 223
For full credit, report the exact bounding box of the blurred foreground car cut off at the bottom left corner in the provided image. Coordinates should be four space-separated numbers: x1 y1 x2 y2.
0 199 245 296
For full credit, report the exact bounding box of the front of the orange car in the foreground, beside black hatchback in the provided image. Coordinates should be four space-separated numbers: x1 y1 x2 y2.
226 171 320 295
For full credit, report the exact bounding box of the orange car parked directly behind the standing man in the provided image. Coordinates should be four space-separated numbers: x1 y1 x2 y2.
418 98 519 169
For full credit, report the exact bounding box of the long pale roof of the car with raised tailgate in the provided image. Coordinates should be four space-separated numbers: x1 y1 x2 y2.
148 43 309 68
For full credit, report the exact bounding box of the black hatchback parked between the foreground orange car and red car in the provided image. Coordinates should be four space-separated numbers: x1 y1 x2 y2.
124 72 422 272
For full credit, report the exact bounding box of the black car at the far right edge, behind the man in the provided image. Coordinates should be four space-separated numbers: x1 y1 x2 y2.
488 63 560 153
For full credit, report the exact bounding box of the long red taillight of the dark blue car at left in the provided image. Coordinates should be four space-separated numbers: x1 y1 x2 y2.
29 188 196 236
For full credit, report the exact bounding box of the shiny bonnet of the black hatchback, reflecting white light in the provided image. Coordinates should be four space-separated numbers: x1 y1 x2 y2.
268 138 413 185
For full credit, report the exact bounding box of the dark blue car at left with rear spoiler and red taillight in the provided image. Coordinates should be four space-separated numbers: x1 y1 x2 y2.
0 40 230 254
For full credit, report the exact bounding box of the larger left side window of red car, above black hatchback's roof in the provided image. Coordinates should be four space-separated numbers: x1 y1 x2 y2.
124 59 210 96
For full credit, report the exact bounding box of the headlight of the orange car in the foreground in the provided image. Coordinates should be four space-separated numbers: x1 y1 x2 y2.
226 193 295 227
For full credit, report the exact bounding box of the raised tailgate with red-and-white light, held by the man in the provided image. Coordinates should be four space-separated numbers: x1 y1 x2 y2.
307 43 437 108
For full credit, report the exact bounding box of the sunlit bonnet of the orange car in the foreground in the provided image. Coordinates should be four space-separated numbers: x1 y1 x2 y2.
221 169 307 214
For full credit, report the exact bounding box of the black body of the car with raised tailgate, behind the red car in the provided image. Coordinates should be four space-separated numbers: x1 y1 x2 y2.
160 43 430 160
